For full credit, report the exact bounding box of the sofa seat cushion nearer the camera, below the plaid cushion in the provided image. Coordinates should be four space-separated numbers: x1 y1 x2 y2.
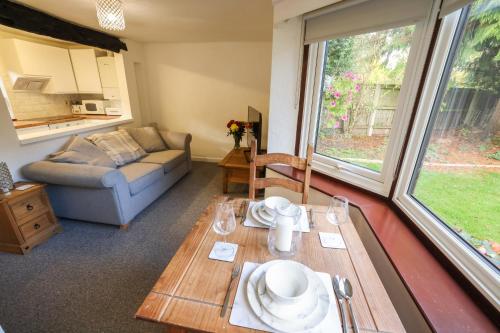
120 163 163 195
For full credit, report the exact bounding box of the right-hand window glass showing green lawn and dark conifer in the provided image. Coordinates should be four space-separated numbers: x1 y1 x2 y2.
410 0 500 267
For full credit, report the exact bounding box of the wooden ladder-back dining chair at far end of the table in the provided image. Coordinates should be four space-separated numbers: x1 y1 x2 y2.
249 139 313 204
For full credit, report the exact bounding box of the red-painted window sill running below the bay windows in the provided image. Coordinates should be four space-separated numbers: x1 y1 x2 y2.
268 165 498 333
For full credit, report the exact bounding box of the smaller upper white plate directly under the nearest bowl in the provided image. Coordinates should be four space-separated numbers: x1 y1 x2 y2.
257 274 318 320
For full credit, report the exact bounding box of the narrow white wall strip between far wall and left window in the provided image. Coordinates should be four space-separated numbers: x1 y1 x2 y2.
268 17 302 154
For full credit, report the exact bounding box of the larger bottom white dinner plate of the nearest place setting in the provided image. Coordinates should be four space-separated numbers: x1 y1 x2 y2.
247 260 331 332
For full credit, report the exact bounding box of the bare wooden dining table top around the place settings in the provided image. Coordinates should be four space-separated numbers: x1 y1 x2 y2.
136 199 405 333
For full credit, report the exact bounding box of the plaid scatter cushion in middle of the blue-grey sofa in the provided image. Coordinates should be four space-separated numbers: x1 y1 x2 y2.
87 129 147 166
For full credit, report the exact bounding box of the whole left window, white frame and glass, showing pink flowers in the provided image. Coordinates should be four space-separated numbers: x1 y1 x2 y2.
301 22 429 196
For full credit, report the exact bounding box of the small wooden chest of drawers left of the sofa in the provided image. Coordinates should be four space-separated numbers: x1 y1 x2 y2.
0 183 62 254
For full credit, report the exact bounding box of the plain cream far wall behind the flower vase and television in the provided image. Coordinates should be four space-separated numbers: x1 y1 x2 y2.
144 42 271 161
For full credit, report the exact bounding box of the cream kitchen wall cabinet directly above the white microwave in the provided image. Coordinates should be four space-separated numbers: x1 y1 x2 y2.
69 49 102 94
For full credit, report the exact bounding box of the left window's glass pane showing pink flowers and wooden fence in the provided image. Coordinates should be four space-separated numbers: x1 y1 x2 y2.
316 26 414 171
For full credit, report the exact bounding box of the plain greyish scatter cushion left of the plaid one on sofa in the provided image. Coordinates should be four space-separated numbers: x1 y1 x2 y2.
49 135 116 168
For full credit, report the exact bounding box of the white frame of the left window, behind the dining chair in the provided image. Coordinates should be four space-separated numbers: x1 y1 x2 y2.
299 4 439 197
